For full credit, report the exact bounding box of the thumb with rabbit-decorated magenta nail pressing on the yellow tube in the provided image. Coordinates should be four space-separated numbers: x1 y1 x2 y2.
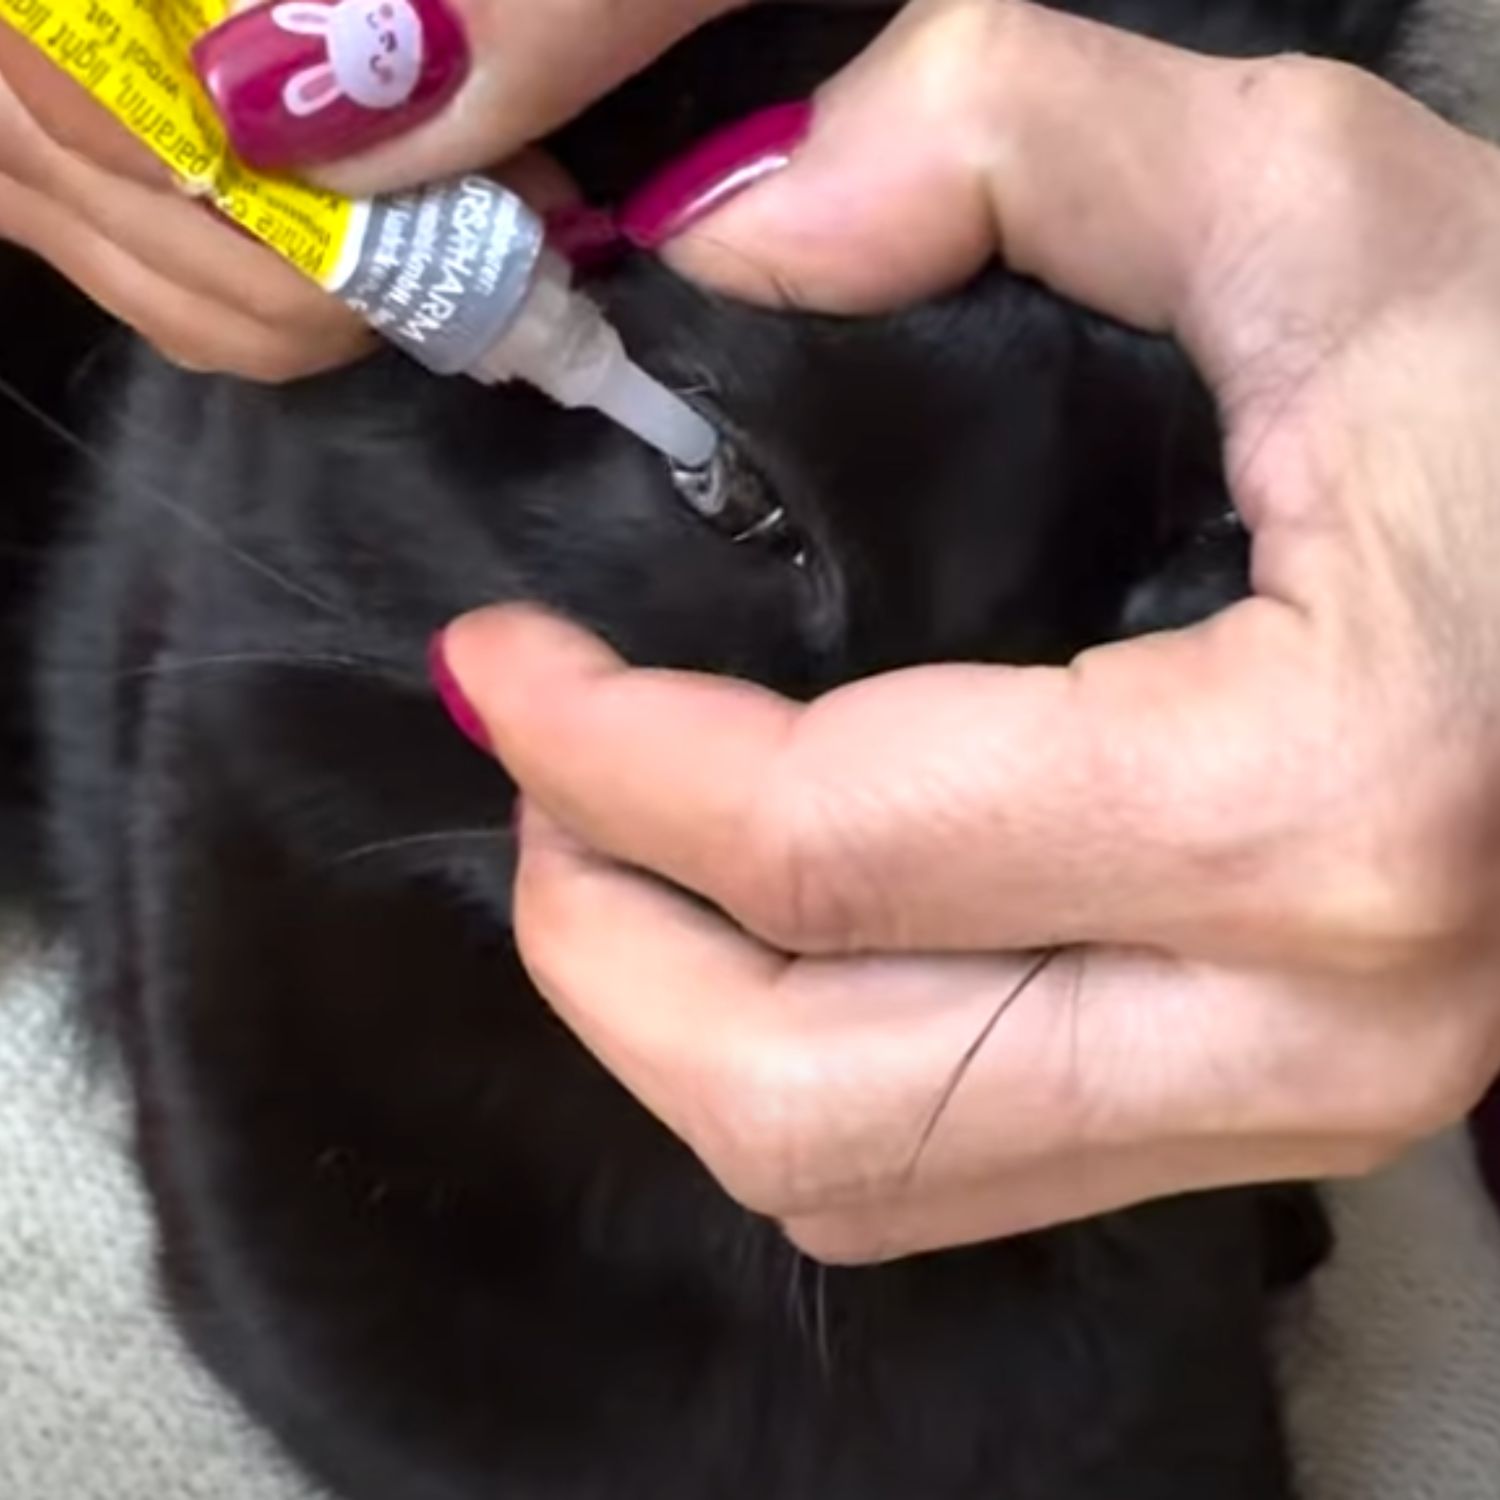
195 0 746 195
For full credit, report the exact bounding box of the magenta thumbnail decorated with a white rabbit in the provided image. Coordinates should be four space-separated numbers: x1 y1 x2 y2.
192 0 468 168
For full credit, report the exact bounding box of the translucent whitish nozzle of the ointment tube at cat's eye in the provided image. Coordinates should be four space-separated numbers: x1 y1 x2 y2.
473 251 719 470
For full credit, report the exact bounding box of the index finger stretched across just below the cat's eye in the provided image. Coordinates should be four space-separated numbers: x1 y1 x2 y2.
446 600 1440 963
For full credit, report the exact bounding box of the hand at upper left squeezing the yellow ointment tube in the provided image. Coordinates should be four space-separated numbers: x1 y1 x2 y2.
0 0 750 381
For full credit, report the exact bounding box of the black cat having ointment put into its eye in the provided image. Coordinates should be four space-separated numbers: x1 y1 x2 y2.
41 0 1470 1500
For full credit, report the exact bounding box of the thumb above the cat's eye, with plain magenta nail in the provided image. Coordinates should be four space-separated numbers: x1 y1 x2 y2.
654 0 1230 327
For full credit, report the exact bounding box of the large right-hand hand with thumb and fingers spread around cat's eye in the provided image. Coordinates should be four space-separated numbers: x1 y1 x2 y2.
446 0 1500 1260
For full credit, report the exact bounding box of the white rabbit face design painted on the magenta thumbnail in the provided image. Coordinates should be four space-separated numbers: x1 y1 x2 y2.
272 0 422 116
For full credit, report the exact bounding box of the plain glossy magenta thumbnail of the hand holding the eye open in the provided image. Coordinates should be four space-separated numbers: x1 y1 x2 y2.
620 101 813 251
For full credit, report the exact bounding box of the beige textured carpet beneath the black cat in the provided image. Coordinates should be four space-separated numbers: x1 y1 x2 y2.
0 912 1500 1500
